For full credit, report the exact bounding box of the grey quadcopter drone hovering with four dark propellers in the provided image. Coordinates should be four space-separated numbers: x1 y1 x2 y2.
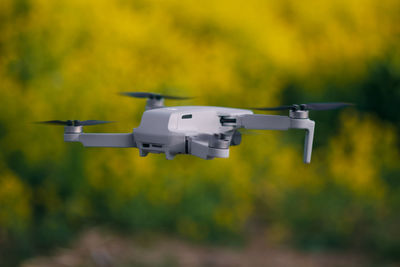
40 92 352 163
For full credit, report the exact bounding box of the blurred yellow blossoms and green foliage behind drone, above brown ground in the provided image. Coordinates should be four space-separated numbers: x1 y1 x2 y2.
0 0 400 265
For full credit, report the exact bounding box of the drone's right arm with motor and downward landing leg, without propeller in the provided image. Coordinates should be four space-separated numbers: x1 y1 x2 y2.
237 111 315 163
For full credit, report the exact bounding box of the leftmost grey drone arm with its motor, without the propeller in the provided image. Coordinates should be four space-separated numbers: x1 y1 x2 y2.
64 126 136 147
